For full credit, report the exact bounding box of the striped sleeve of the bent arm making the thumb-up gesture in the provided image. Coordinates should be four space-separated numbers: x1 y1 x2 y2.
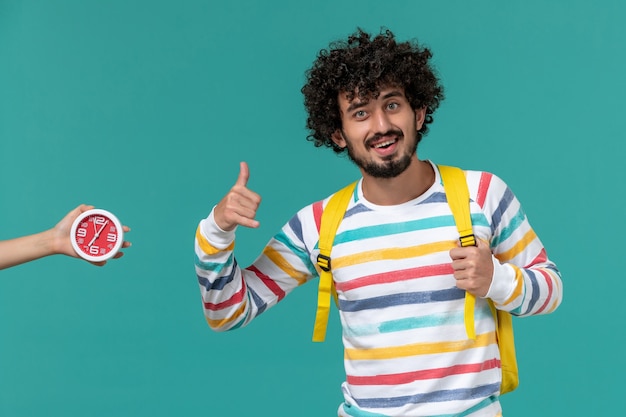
195 206 318 331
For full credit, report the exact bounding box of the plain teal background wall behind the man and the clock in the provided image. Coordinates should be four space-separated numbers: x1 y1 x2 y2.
0 0 626 417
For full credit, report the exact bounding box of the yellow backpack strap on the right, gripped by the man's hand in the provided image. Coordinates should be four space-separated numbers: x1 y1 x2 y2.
439 165 476 339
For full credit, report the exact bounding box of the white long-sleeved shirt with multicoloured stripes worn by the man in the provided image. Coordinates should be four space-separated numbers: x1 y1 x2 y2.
195 161 562 417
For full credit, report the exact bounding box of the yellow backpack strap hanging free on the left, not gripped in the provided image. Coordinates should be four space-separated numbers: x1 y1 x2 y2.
313 181 356 342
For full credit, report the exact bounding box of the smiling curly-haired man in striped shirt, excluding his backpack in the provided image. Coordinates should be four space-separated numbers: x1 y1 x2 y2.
195 30 562 417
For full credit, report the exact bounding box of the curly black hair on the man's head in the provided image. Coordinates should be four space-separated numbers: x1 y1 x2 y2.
301 28 444 153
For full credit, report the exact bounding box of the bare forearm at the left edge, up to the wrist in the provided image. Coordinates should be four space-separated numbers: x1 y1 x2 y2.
0 230 56 269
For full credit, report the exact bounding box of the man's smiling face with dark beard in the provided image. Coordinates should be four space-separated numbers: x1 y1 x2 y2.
332 87 426 178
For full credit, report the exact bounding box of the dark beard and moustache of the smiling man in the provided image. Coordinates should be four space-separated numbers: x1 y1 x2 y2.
342 130 417 178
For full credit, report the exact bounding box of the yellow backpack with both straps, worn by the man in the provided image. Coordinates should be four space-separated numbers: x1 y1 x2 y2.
313 165 519 394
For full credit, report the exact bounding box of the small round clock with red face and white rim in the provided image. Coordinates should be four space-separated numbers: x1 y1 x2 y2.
70 209 124 262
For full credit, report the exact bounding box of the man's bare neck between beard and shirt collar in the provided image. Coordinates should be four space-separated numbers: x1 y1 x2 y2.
363 155 435 206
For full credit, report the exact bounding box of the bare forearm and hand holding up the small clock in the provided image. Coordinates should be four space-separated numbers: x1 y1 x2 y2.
0 204 130 269
